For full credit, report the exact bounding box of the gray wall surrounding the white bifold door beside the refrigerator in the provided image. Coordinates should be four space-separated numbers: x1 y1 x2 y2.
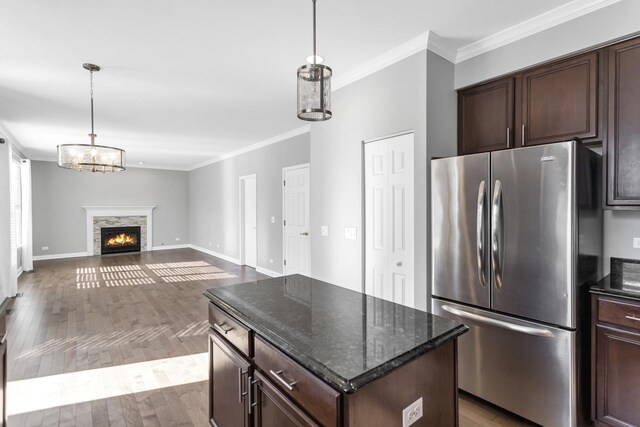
311 51 456 309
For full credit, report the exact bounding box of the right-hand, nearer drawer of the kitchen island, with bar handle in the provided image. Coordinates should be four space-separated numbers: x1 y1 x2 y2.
254 337 340 426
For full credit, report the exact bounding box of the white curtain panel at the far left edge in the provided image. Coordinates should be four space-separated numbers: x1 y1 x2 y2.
0 139 11 303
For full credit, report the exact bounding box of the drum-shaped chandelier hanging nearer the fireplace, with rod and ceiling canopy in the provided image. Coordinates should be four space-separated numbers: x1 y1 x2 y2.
58 64 125 173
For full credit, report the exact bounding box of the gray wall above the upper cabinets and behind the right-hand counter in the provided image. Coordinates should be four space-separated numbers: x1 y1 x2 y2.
455 0 640 273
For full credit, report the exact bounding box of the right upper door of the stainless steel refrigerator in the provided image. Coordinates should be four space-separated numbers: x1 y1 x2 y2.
491 142 576 328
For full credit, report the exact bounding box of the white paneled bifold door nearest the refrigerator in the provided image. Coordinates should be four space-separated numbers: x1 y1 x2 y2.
364 134 415 307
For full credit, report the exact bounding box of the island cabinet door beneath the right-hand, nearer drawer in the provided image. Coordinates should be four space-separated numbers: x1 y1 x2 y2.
252 371 320 427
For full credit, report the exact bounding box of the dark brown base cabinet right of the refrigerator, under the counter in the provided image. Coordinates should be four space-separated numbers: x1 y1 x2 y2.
592 295 640 426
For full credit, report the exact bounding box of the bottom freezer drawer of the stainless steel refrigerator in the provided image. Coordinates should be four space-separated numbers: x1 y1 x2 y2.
432 300 579 427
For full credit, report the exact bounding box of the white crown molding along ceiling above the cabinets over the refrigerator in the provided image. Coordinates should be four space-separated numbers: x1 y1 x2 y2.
455 0 621 63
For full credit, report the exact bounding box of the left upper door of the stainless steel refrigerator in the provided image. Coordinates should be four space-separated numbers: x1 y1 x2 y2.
431 153 490 307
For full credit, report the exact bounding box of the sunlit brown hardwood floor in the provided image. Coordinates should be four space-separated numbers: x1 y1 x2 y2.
7 249 526 427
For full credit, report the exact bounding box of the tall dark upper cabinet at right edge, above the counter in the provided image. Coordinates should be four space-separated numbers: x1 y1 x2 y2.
605 38 640 208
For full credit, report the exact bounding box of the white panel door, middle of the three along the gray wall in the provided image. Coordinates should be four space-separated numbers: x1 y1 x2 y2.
283 165 311 276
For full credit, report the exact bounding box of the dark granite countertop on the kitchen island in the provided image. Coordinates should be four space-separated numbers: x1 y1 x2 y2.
205 275 468 393
